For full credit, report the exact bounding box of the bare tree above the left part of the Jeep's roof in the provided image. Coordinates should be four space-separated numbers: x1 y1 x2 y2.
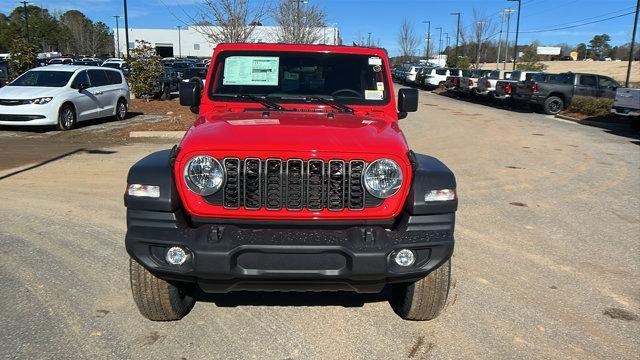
189 0 268 44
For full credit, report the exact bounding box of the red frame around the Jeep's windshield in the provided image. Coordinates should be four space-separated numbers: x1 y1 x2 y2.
206 49 393 107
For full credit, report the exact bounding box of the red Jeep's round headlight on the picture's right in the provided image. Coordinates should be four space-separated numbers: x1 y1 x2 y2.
364 159 402 199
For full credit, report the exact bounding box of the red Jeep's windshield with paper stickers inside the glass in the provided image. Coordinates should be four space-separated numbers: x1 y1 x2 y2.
209 51 390 104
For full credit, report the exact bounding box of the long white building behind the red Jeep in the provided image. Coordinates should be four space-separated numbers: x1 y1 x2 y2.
113 26 340 58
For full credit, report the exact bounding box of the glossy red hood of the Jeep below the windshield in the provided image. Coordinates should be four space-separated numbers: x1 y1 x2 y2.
180 111 409 156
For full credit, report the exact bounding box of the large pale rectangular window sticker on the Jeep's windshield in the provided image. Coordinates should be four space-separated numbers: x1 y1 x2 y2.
222 56 280 86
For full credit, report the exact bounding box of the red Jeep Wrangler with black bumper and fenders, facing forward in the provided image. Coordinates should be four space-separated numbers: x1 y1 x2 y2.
124 44 458 320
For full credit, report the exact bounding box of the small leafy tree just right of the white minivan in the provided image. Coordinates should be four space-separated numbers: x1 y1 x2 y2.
129 40 163 98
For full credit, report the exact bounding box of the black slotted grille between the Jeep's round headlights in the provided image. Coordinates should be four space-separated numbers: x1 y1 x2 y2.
204 157 383 211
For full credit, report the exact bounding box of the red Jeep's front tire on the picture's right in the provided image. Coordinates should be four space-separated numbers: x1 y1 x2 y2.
390 260 451 321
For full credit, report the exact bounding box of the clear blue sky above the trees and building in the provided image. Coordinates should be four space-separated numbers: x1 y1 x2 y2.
0 0 640 55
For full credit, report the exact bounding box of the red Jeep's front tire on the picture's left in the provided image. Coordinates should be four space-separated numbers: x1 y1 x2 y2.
129 259 195 321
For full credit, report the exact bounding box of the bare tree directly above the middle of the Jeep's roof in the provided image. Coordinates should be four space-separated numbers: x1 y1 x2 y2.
272 0 327 44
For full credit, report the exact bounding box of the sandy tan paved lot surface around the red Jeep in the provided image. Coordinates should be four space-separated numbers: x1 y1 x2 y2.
0 88 640 359
